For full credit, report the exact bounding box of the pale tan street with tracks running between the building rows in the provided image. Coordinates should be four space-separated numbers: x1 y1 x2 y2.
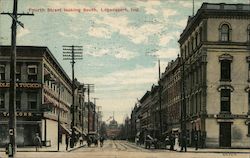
0 140 250 158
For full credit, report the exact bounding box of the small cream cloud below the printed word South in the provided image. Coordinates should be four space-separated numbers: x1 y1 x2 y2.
88 27 112 38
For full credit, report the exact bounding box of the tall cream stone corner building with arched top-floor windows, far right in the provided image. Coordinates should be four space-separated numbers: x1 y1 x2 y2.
179 3 250 148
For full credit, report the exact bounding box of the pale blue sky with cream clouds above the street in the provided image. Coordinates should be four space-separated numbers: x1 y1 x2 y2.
0 0 250 123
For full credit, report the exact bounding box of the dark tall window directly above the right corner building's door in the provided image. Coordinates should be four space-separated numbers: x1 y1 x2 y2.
220 89 231 112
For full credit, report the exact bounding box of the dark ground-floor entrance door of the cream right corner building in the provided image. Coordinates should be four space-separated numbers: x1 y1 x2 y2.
219 122 231 147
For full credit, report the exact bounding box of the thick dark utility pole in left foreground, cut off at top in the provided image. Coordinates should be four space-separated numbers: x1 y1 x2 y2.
1 0 34 157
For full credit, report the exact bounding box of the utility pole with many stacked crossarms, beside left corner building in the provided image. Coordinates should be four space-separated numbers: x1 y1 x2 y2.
63 45 82 148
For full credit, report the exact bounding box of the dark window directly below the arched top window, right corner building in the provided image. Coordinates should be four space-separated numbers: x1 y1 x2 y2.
221 60 231 81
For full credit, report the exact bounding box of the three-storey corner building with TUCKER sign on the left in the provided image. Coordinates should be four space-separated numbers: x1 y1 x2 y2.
0 46 84 147
